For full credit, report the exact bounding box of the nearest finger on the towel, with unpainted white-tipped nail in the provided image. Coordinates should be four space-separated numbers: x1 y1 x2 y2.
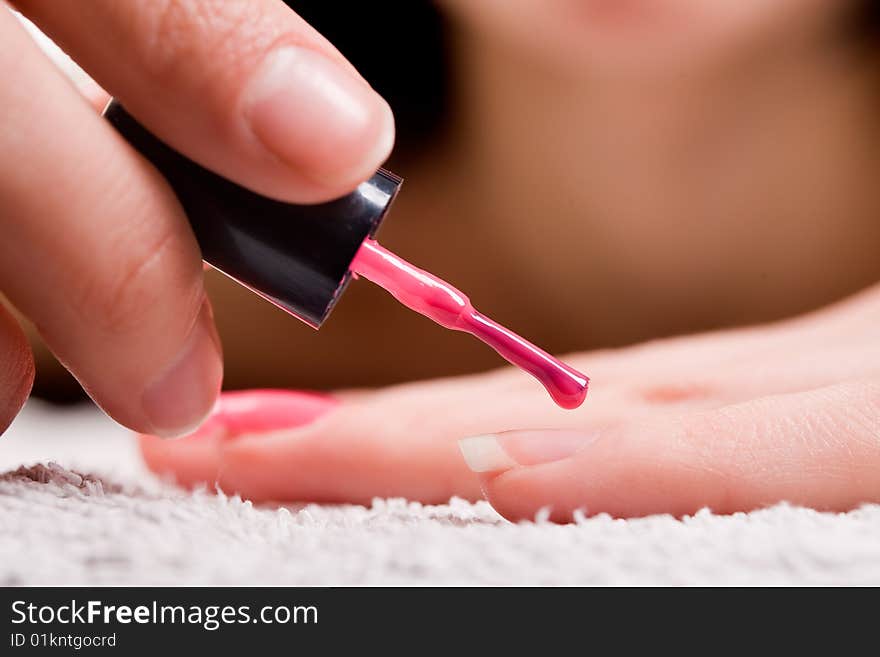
461 382 880 522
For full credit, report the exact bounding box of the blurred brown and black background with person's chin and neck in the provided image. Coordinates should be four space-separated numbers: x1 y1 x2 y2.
27 0 880 401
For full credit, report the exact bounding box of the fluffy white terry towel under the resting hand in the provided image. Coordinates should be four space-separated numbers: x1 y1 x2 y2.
0 402 880 585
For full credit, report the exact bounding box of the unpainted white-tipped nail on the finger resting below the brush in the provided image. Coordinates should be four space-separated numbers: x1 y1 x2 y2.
458 429 598 472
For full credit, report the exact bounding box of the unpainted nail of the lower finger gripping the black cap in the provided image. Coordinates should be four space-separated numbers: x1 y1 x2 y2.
142 300 223 438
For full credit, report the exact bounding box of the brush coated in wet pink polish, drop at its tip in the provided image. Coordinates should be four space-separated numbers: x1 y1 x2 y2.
351 239 590 408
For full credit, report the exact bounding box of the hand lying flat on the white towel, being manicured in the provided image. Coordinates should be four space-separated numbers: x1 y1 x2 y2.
141 288 880 522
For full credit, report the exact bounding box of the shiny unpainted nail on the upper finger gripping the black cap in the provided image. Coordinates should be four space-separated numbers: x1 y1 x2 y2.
245 46 394 185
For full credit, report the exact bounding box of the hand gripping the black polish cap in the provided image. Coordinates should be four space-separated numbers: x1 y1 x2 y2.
0 5 394 435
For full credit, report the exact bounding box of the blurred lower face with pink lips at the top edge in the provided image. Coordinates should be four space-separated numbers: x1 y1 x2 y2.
442 0 854 74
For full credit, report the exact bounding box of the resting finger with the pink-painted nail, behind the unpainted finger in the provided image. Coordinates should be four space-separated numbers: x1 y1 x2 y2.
142 368 652 502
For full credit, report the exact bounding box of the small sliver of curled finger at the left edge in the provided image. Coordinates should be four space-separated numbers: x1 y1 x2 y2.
0 302 34 434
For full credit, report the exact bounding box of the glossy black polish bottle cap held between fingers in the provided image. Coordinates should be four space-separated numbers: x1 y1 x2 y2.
104 100 402 329
